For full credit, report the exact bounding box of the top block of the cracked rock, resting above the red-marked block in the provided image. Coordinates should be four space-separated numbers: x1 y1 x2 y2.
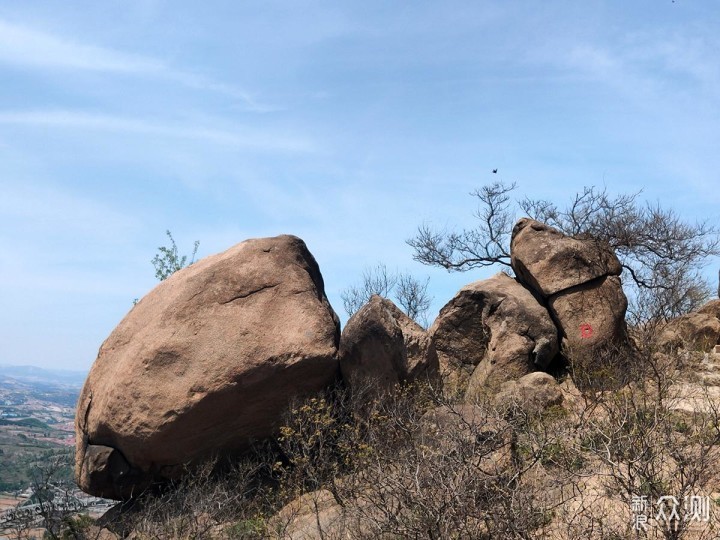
510 218 622 298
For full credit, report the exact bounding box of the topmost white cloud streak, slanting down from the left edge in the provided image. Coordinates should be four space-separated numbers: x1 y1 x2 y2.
0 20 277 112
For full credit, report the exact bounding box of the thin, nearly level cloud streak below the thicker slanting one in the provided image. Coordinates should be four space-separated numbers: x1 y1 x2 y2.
0 110 316 153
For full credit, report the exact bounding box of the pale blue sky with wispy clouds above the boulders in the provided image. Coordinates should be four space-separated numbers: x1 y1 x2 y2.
0 0 720 369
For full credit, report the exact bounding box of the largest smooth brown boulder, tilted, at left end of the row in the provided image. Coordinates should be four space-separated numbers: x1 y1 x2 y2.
75 236 339 499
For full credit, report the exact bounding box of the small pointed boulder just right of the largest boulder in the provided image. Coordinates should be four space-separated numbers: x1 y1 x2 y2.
339 295 438 393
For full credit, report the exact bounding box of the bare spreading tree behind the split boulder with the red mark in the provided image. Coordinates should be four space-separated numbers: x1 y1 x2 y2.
407 182 720 321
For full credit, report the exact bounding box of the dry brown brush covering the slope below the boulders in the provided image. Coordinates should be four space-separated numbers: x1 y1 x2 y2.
91 340 720 539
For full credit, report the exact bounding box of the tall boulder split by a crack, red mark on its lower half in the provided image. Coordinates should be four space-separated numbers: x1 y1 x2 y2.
510 218 627 352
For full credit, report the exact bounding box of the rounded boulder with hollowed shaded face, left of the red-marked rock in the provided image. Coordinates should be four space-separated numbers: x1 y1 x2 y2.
430 273 558 392
